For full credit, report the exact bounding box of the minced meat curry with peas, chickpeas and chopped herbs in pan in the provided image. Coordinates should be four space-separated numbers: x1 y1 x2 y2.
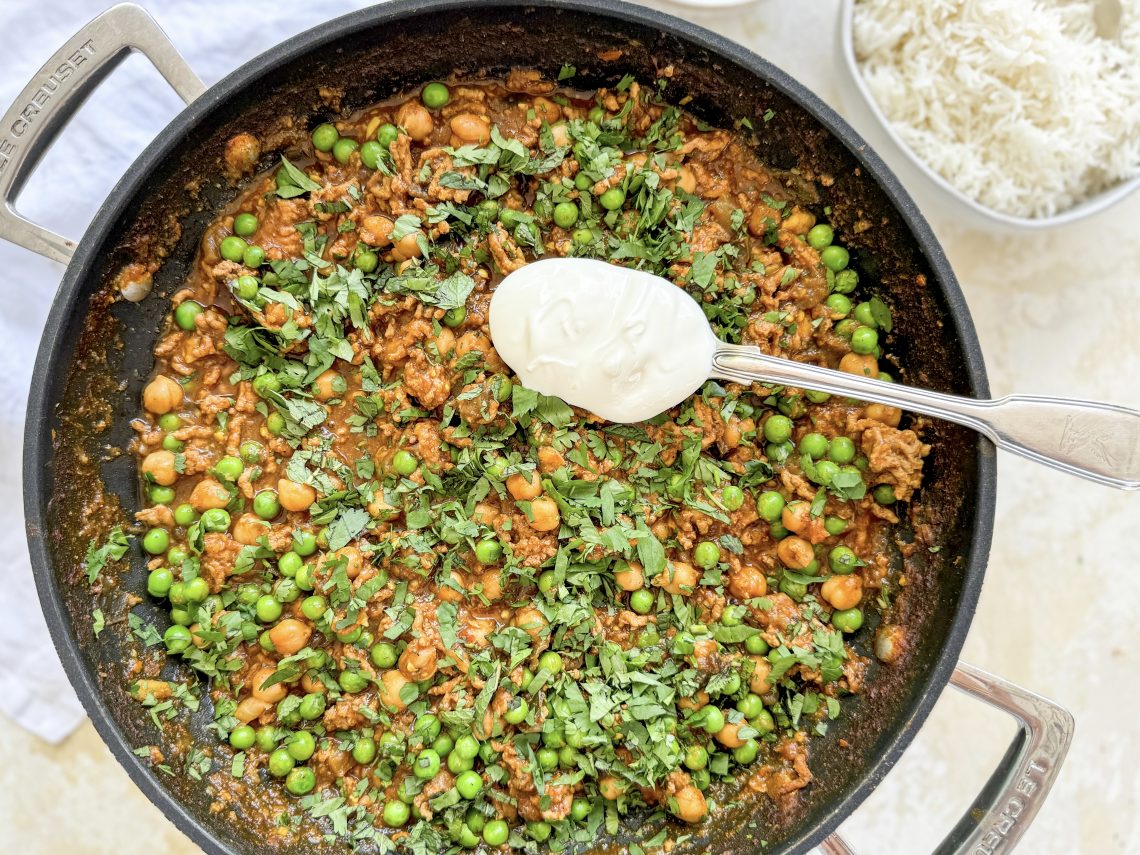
124 71 929 853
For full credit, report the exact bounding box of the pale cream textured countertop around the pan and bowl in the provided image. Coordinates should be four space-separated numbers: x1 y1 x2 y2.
0 0 1140 855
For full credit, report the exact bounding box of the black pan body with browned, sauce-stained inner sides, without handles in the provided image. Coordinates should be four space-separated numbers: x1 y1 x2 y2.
25 2 993 853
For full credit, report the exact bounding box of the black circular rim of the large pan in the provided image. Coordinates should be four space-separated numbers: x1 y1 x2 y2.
23 0 996 855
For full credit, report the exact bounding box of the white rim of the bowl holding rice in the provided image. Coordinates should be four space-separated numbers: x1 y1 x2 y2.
839 0 1140 231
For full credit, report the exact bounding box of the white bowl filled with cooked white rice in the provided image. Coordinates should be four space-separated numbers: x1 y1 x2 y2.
839 0 1140 229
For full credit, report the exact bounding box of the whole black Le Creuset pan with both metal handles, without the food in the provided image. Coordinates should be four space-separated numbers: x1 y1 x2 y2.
0 0 1072 854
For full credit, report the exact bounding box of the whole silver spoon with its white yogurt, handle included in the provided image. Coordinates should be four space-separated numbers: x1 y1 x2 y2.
490 259 1140 490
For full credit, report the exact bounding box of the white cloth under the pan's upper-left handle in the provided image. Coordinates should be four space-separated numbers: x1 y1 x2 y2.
0 0 364 742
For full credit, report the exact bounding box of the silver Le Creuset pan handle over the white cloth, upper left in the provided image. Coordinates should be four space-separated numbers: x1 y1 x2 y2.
0 3 206 263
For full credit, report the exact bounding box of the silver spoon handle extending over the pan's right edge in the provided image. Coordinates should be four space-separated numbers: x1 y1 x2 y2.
711 342 1140 490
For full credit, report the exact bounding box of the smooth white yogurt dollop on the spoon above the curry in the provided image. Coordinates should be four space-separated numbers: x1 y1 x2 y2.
490 259 716 422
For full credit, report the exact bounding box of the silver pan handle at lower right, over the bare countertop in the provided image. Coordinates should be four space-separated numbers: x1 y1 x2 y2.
820 662 1074 855
